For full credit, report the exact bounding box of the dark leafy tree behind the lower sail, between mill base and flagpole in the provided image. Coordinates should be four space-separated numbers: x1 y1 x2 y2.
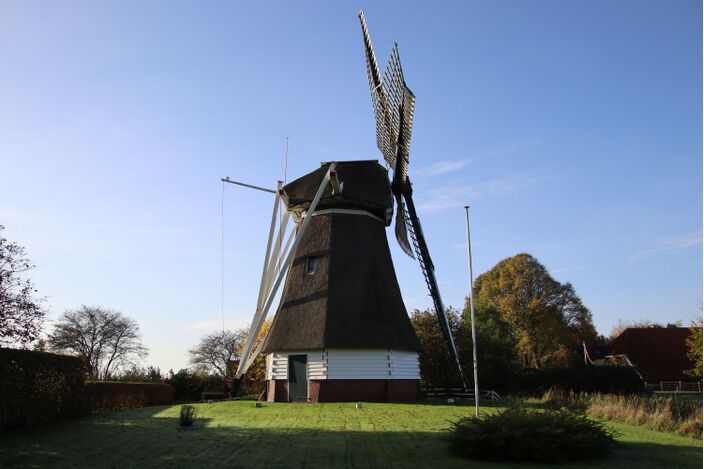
411 308 464 388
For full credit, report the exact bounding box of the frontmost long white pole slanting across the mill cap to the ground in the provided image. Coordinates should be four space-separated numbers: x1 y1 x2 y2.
235 163 335 378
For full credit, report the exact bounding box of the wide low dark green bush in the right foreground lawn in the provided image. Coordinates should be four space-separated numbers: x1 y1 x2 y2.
450 408 616 463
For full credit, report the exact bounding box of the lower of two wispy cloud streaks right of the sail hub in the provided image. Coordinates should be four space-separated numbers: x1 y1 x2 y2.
419 172 552 213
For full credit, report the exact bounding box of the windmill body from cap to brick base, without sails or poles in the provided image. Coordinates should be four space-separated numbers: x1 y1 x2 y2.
263 161 420 402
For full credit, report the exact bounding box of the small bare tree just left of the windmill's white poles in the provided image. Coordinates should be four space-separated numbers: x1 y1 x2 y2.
188 330 247 378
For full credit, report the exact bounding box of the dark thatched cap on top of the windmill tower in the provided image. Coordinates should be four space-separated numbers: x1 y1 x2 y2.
284 160 393 220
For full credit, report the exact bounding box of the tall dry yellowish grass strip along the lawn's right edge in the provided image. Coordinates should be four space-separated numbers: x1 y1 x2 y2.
527 390 702 440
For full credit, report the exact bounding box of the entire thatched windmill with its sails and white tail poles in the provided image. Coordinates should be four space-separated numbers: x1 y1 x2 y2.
231 12 464 401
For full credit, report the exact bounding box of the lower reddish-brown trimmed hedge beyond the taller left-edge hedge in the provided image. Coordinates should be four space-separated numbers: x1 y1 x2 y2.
84 381 174 412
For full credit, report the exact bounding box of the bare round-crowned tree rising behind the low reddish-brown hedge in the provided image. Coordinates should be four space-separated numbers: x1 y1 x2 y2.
49 305 148 379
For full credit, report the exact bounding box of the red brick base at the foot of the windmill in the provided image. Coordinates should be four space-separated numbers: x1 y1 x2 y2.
266 379 420 402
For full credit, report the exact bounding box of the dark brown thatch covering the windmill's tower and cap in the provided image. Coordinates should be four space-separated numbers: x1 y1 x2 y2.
264 162 420 352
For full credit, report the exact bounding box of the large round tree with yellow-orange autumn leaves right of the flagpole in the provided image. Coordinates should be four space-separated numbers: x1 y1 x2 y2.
465 253 597 368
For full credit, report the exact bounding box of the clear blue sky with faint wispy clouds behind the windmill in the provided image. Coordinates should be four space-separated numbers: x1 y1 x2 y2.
0 1 702 369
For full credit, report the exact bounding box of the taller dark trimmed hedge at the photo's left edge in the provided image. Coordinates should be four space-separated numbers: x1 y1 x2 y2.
0 348 86 430
